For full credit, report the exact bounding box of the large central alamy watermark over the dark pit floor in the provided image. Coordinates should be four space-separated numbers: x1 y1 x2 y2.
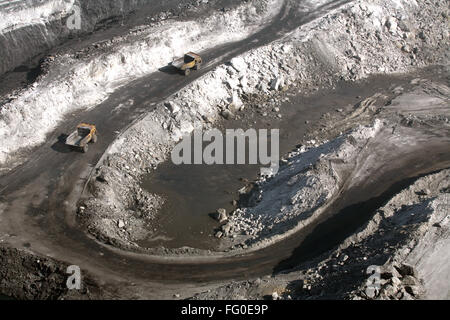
171 129 280 176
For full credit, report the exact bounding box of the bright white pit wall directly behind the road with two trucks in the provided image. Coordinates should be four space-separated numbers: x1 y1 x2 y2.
0 0 282 170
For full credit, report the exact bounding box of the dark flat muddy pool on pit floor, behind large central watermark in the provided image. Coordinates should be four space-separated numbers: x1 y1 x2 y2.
140 71 430 249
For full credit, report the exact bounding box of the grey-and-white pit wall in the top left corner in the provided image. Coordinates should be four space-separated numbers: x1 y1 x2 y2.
0 0 213 75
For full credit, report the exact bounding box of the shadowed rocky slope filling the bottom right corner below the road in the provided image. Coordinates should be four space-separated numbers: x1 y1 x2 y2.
192 170 450 300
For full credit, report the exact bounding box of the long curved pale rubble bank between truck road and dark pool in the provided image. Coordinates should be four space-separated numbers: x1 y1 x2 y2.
79 0 448 251
